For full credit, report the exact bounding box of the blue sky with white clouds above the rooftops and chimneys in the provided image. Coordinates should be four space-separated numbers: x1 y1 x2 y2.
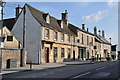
4 2 118 44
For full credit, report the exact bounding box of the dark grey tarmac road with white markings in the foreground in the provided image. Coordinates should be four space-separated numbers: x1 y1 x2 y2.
2 61 120 80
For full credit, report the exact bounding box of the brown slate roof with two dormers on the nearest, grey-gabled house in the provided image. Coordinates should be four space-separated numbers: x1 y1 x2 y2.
26 4 77 36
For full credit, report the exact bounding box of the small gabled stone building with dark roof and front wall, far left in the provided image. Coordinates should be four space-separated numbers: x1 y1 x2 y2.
0 18 26 68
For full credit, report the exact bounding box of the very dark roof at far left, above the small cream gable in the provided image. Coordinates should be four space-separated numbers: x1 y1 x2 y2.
0 18 16 31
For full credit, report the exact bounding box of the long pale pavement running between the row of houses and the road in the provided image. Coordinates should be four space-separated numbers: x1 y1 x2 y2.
1 61 103 74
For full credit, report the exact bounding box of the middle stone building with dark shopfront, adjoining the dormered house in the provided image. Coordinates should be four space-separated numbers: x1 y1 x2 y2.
69 24 95 60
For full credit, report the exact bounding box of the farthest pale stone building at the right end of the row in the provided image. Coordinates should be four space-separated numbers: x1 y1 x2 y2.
94 27 111 59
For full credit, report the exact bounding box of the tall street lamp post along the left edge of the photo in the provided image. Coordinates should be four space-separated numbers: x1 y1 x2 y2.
0 0 6 73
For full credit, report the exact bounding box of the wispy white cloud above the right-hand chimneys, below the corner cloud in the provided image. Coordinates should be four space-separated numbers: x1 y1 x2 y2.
82 10 108 22
